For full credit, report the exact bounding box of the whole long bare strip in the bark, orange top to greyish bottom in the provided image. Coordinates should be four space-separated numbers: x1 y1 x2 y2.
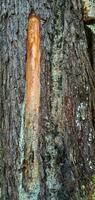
23 15 40 191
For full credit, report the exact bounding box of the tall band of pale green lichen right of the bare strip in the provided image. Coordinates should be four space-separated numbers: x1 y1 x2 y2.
39 1 64 200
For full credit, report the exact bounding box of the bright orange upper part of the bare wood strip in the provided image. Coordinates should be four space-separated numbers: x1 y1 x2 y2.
26 15 40 117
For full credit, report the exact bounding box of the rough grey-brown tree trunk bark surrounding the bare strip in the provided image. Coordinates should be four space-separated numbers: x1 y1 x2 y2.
0 0 95 200
